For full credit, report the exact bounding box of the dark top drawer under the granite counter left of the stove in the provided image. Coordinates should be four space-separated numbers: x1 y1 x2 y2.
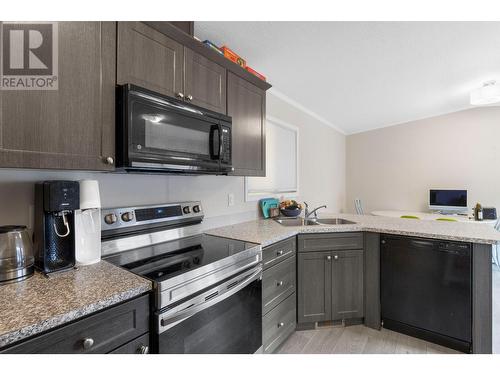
4 296 149 354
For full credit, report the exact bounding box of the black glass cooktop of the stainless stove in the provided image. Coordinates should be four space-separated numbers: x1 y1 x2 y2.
106 234 257 281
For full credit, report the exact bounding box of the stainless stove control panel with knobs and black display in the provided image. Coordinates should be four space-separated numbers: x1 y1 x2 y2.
102 201 203 232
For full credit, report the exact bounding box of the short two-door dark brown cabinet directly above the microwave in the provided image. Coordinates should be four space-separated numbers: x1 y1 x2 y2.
117 22 226 114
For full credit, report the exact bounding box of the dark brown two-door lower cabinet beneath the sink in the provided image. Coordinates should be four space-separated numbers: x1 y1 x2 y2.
297 234 364 323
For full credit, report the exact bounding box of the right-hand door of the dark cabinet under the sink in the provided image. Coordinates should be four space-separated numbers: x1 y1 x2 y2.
332 250 363 320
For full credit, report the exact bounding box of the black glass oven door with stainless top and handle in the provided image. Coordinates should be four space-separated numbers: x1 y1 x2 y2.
153 266 262 354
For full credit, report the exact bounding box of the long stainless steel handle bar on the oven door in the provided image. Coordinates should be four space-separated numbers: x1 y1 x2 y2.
158 267 262 332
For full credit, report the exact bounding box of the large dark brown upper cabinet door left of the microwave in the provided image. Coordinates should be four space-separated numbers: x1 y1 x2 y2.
0 22 116 170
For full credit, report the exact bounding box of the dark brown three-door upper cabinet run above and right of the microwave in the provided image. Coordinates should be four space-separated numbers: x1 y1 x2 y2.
117 22 271 176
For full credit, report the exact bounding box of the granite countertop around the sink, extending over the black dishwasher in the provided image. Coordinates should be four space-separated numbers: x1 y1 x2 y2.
206 214 500 246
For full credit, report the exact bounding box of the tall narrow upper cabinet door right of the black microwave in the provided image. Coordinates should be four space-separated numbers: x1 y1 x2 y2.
227 72 266 176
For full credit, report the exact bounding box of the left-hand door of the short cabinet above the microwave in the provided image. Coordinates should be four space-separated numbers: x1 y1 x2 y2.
116 22 184 96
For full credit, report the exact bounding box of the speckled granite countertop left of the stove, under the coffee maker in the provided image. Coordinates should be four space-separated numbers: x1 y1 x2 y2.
0 261 152 348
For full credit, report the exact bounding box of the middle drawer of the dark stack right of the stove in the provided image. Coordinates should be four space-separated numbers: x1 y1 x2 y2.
262 256 296 315
